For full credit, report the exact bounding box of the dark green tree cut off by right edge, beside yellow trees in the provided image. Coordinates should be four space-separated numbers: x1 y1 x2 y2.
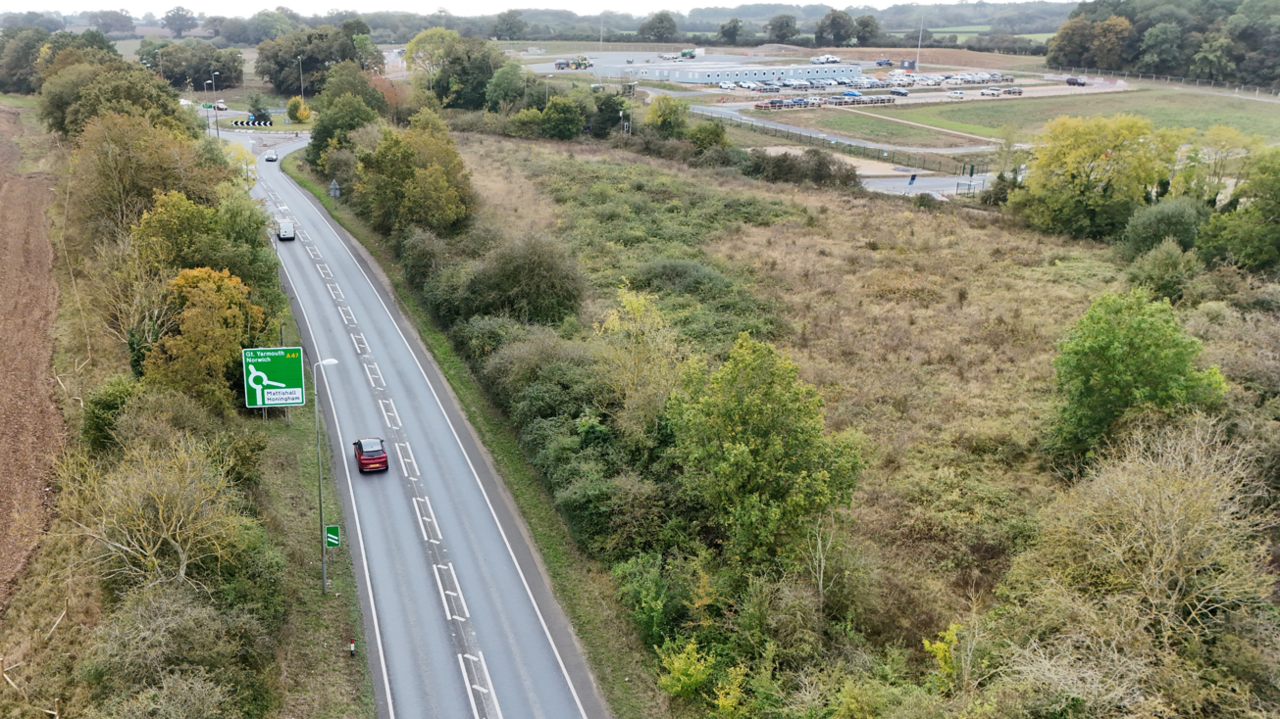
1197 148 1280 271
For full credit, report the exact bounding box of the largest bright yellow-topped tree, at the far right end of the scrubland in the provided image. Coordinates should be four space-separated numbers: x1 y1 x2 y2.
1010 115 1185 238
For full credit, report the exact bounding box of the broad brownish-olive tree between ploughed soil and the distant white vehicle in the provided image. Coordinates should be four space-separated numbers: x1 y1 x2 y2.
69 113 230 239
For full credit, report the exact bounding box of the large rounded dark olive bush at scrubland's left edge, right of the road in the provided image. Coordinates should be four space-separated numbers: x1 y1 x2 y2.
466 237 586 324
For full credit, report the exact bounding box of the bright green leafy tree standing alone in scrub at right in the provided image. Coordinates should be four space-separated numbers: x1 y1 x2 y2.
1050 288 1226 458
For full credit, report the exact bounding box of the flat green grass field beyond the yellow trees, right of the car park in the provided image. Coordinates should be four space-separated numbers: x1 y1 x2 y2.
868 88 1280 141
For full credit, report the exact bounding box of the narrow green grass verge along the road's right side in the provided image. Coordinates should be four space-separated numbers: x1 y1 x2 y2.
282 152 667 719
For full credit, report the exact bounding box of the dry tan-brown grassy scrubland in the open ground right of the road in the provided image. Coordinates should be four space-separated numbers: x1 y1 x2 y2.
460 136 1123 632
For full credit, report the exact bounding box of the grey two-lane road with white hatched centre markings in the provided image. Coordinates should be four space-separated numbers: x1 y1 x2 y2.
248 136 608 719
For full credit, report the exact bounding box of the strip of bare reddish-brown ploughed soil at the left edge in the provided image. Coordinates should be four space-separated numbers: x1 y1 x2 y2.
0 107 63 608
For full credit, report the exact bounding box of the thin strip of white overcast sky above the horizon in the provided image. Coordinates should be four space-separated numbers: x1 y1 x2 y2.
52 0 900 18
